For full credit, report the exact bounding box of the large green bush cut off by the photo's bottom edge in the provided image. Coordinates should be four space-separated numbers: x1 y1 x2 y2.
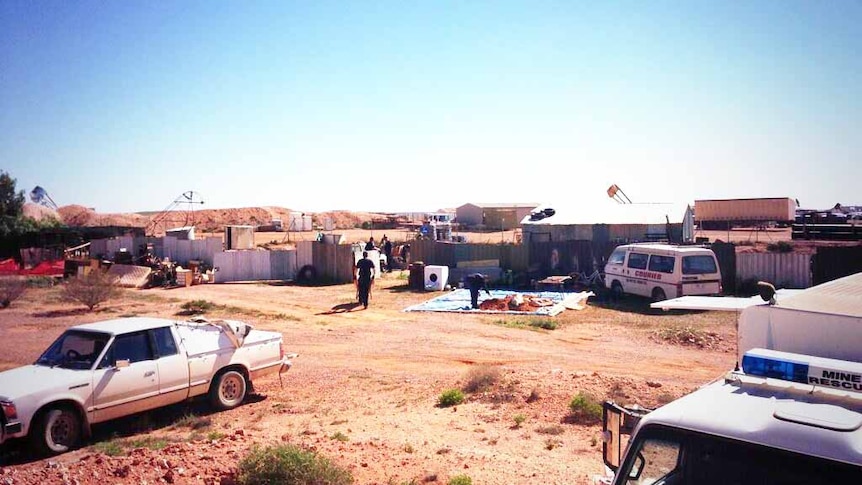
237 445 353 485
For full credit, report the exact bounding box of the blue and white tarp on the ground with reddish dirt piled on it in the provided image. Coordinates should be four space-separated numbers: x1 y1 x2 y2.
404 289 594 316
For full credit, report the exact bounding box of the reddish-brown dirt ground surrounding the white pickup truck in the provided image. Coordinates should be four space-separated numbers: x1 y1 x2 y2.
0 273 736 484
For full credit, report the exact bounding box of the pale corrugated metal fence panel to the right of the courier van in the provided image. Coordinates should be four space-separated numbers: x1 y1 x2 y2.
736 253 813 288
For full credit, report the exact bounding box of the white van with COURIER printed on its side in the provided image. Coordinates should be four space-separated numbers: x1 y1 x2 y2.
605 244 721 301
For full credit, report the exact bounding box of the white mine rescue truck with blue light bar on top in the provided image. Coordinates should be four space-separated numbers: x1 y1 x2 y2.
597 273 862 485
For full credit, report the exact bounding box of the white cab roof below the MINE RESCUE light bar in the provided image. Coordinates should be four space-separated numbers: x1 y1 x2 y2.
640 376 862 465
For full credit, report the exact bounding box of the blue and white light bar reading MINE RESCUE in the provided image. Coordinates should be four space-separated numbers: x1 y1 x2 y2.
742 349 862 393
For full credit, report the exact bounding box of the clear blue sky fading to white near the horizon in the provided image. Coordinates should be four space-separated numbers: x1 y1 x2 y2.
0 0 862 212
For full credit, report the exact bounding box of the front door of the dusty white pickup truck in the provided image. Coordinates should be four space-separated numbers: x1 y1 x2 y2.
93 330 159 422
